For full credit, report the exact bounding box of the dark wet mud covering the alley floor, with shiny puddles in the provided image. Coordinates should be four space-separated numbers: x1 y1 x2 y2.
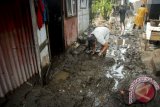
1 15 160 107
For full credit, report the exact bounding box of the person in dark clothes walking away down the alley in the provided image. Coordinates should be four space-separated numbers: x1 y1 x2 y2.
119 6 129 35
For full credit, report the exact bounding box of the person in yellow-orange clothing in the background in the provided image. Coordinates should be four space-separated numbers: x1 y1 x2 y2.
133 4 148 29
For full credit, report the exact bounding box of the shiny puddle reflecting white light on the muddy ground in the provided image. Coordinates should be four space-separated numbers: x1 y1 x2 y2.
105 37 130 90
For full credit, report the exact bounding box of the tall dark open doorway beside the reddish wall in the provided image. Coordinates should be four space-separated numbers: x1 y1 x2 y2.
47 0 65 58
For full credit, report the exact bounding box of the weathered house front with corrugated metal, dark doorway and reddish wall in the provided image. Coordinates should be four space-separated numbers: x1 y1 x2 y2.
0 0 82 97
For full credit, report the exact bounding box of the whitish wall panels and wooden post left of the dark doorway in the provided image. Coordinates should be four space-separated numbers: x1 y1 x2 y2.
29 0 50 73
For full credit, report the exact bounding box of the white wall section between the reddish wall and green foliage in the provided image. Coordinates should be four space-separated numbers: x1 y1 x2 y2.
77 0 89 35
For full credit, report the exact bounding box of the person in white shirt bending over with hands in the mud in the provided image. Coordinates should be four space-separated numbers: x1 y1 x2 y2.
88 27 110 56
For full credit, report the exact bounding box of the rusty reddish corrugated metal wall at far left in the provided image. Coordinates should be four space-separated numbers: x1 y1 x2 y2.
0 0 38 97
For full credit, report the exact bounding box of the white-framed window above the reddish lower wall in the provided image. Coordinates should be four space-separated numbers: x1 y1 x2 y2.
66 0 77 17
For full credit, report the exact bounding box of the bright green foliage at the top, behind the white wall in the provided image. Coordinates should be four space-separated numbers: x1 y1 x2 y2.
92 0 112 17
